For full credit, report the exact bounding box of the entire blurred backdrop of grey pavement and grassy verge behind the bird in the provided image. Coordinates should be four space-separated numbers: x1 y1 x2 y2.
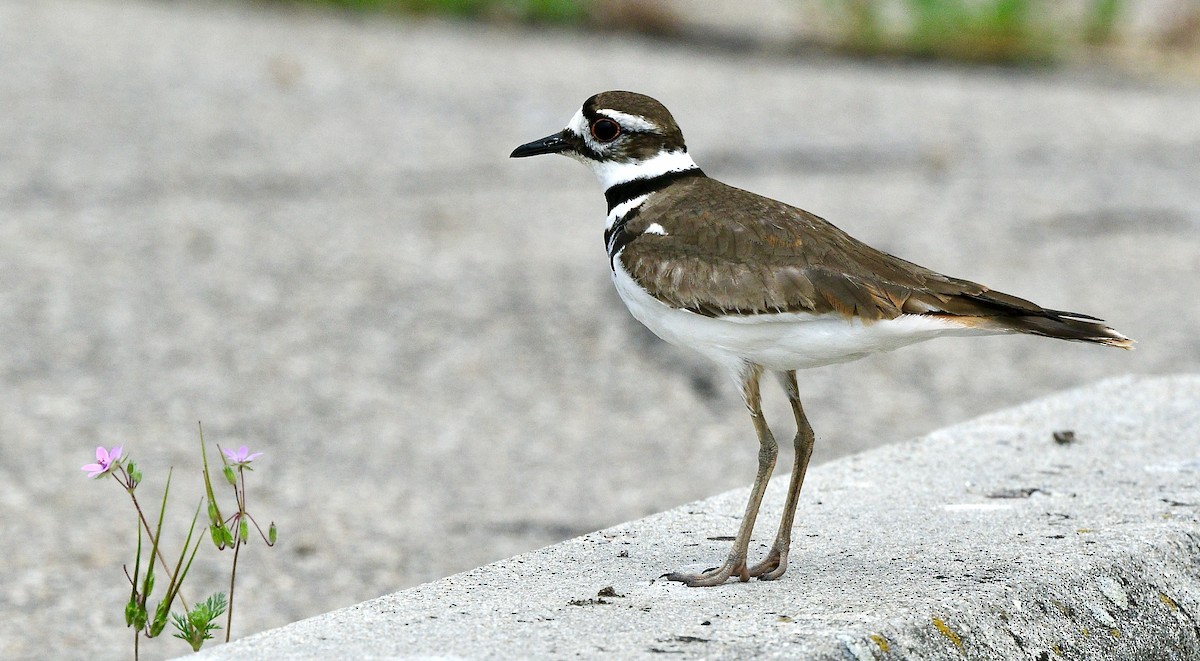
0 0 1200 659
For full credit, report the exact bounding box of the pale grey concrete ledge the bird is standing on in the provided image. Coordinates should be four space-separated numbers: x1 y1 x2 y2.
196 375 1200 661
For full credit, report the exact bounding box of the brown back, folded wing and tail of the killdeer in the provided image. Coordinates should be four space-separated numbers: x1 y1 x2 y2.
620 178 1128 345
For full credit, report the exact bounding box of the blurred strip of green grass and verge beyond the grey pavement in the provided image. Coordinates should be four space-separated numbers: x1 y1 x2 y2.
295 0 1200 76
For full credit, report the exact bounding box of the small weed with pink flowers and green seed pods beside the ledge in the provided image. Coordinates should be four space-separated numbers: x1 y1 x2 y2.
82 428 277 659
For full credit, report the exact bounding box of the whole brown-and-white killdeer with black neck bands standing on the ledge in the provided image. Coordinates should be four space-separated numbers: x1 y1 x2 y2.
511 91 1133 585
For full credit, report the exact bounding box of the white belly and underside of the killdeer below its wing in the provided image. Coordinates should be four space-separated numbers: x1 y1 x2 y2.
613 257 994 371
